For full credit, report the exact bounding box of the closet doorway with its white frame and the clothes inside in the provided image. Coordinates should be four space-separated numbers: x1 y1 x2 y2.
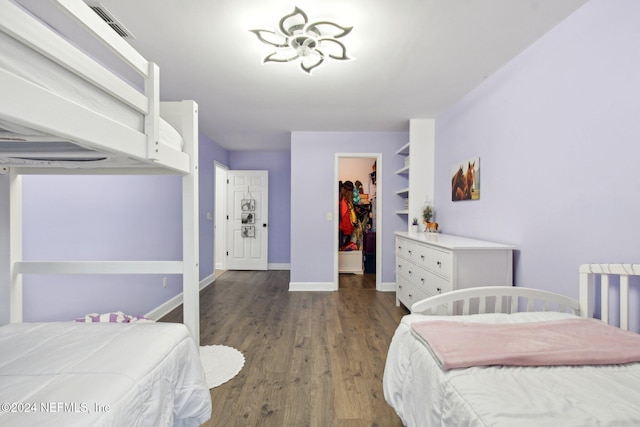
334 153 382 290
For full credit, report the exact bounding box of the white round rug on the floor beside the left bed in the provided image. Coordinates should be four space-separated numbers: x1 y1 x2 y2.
200 345 244 388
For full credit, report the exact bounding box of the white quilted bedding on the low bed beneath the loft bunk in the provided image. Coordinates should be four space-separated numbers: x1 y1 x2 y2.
0 322 211 427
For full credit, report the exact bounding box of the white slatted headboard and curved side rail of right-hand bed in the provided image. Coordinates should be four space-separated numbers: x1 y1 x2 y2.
411 264 640 330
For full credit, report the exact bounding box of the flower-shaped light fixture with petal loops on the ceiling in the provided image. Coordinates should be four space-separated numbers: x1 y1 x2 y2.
249 7 353 74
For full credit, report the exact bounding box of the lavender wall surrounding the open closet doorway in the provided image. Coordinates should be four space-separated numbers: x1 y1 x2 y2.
290 132 409 283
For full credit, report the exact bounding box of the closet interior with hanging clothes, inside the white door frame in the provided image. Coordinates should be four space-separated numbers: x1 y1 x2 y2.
336 157 377 288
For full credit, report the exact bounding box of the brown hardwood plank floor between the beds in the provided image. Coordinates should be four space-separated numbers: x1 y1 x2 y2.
162 271 407 427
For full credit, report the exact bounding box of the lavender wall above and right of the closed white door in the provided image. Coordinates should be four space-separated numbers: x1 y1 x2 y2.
229 151 291 265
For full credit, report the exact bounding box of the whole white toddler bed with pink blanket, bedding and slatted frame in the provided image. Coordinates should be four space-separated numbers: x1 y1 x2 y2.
383 264 640 427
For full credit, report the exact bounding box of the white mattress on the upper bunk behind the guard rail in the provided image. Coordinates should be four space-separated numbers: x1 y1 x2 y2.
0 31 184 151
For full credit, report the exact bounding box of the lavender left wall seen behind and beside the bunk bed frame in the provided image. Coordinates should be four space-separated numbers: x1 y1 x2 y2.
23 137 229 321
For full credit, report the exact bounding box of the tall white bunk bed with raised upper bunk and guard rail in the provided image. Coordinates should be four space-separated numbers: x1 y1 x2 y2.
0 0 199 344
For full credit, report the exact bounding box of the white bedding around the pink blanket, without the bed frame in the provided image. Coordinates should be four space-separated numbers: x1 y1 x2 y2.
383 313 640 427
